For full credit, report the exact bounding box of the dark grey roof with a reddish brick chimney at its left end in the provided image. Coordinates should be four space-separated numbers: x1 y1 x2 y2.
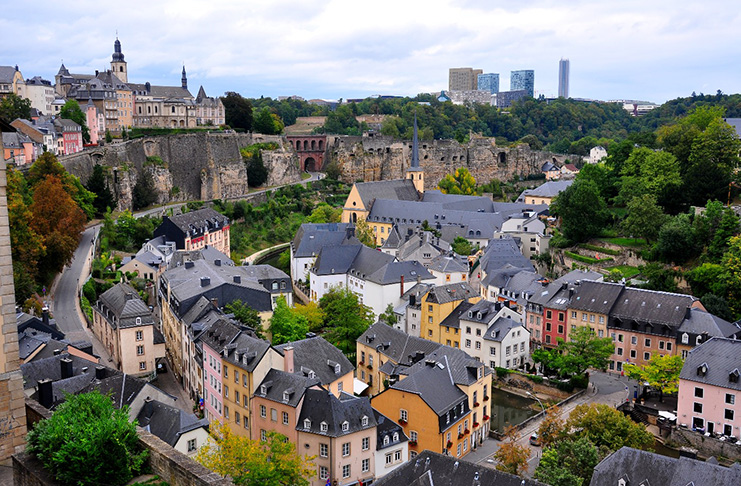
275 336 355 385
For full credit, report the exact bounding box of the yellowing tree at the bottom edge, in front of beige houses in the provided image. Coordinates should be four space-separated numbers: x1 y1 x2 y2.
196 424 315 486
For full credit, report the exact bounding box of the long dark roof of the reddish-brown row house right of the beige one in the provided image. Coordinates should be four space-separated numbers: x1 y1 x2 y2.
602 284 697 327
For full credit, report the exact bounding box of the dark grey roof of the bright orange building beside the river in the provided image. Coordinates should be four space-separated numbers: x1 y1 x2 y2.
390 356 468 417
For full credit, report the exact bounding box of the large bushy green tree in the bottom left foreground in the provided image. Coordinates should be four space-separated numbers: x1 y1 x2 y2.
28 391 147 486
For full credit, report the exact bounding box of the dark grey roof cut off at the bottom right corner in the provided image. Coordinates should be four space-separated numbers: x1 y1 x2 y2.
588 447 741 486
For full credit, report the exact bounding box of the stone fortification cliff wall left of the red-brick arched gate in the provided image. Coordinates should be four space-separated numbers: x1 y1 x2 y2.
60 132 301 209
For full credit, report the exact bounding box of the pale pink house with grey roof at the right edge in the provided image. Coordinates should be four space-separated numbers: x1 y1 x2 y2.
677 337 741 438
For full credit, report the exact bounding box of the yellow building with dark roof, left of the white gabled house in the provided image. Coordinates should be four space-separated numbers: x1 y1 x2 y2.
420 282 481 348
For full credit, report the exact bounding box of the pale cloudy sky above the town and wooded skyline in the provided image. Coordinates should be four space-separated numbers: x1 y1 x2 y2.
0 0 741 102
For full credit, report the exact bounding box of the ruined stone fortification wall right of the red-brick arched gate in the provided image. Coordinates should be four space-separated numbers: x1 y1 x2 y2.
327 136 579 188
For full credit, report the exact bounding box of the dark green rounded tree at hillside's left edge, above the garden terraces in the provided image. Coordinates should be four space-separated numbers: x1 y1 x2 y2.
550 180 608 242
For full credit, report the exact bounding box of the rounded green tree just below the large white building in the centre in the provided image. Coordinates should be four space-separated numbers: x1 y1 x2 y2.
319 287 374 356
